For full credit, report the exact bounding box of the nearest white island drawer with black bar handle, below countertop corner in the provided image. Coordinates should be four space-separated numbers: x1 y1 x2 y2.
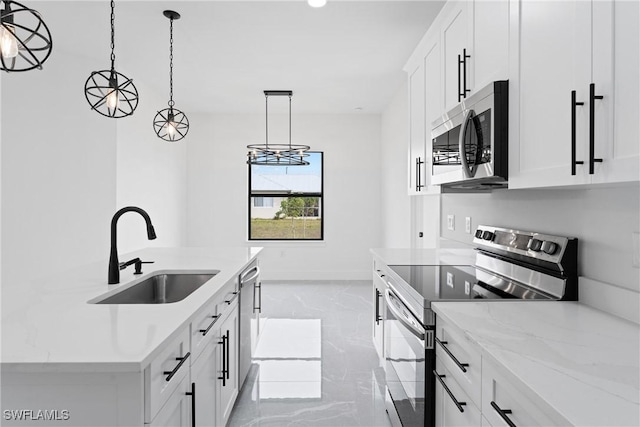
144 328 191 422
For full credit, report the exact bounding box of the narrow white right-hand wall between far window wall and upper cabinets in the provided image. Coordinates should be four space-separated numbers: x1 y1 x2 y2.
380 83 411 248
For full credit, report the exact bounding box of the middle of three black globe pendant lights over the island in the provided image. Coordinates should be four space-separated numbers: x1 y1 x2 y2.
84 0 138 119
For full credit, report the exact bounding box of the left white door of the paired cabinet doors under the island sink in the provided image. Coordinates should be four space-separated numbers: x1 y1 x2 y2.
191 344 218 426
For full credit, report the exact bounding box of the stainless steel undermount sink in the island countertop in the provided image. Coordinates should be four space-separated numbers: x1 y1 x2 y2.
93 271 218 304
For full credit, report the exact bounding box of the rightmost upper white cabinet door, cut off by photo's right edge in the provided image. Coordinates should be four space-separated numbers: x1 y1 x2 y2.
592 0 640 183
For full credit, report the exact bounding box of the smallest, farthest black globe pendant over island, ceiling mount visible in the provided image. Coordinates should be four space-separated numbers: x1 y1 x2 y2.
153 10 189 142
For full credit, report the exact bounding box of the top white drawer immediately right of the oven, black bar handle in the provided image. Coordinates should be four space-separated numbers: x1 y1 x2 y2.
436 317 482 407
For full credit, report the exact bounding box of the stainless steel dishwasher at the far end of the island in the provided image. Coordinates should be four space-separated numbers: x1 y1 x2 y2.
238 260 262 387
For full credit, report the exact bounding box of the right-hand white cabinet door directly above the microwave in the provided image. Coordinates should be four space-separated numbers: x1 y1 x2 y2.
470 0 509 90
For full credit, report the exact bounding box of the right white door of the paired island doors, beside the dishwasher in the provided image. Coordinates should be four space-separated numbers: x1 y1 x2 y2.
216 298 239 426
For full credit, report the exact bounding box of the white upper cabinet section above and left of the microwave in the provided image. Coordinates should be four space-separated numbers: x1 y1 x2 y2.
404 0 510 195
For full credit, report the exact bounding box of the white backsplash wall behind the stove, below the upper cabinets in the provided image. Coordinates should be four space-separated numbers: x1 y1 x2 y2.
440 185 640 298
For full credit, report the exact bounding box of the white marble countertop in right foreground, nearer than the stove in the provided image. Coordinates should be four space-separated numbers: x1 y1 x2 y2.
432 301 640 426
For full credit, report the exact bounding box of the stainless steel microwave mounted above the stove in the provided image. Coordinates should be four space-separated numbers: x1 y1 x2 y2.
431 81 509 192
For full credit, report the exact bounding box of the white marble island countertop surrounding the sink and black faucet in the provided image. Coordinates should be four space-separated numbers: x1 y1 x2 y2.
1 247 262 372
